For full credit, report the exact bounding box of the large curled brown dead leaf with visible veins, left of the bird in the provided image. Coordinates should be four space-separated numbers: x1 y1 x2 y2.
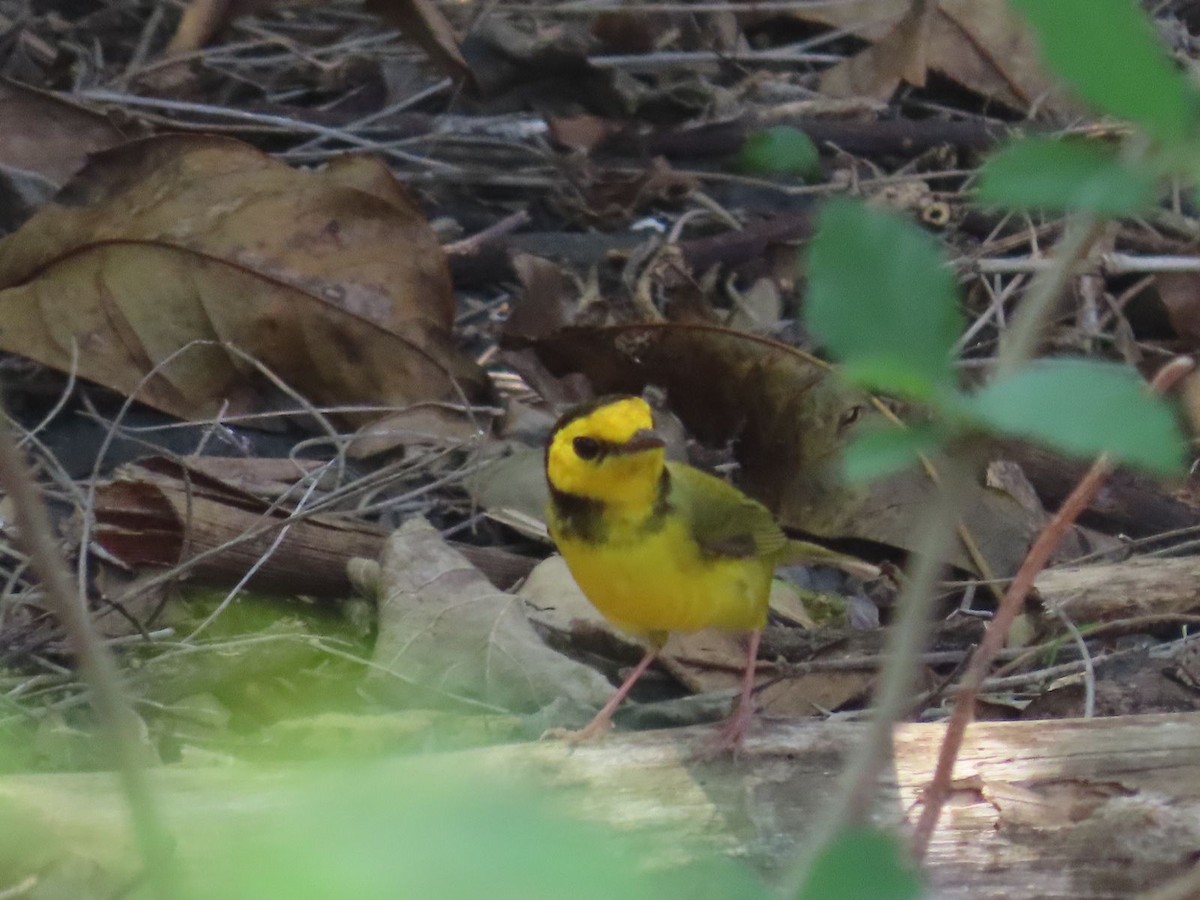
0 136 487 441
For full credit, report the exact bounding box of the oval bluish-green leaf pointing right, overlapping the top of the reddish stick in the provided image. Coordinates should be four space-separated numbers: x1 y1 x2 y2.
962 359 1183 475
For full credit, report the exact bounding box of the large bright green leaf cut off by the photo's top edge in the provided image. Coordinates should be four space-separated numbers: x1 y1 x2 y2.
1012 0 1195 144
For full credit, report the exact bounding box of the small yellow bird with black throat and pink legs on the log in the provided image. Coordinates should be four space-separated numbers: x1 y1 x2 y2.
546 396 877 750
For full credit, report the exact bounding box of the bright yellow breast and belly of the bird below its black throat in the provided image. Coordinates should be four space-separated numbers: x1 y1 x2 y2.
550 515 774 635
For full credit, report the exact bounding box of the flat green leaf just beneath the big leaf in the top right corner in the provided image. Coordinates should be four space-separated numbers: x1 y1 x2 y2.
978 138 1157 216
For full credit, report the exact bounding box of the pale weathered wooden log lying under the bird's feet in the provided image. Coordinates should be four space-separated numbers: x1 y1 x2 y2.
0 714 1200 900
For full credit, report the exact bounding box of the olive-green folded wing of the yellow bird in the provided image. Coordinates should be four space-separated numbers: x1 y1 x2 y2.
667 462 788 559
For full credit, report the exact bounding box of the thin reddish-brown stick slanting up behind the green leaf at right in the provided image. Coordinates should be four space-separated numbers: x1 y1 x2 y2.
912 356 1195 858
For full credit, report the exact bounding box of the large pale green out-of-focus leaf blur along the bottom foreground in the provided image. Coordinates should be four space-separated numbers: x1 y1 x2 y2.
191 762 768 900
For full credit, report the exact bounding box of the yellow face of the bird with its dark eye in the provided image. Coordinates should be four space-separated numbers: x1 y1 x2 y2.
546 397 664 506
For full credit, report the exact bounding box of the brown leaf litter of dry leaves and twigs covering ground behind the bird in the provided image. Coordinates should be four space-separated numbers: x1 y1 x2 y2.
0 0 1200 806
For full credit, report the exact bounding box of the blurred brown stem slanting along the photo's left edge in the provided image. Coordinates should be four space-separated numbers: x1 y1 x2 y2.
0 416 179 900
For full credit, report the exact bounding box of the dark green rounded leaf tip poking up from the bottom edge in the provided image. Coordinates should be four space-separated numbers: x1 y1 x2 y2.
798 827 922 900
